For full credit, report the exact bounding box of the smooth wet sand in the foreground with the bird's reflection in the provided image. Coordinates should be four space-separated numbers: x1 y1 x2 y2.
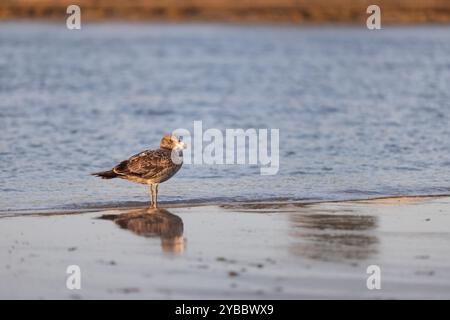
0 197 450 299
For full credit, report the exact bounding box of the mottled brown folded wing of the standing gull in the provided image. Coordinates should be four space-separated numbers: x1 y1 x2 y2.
113 149 174 179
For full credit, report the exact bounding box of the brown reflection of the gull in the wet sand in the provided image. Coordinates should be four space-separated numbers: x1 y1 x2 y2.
100 209 184 252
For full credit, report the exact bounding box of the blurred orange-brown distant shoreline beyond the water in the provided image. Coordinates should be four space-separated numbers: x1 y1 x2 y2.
0 0 450 25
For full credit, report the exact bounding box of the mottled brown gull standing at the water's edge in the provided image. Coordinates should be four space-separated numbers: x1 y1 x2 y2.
92 135 186 208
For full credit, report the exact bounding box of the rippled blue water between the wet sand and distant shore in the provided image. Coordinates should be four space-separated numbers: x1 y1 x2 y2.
0 23 450 211
